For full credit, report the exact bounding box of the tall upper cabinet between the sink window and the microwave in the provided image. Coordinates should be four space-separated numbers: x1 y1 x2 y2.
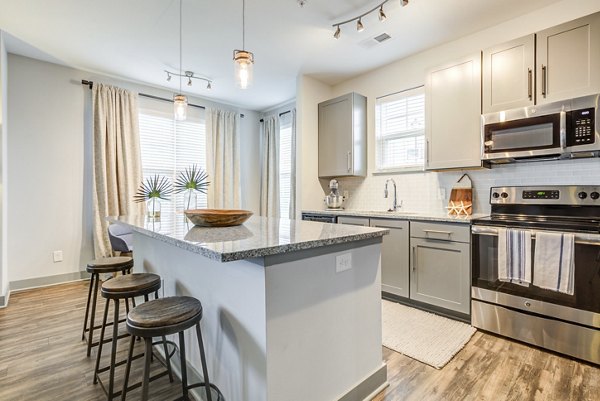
425 53 481 170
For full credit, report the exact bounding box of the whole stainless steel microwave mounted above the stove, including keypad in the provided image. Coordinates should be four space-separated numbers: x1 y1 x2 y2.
481 94 600 163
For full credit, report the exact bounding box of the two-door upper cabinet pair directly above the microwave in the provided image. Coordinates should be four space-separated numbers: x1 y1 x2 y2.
483 13 600 113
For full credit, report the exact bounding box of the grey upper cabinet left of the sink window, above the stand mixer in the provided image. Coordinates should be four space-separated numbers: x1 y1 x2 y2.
319 93 367 177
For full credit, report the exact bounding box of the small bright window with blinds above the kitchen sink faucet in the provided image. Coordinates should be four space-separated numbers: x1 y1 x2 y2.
375 87 425 172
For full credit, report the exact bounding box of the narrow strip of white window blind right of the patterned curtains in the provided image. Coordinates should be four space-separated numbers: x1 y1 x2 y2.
279 113 293 219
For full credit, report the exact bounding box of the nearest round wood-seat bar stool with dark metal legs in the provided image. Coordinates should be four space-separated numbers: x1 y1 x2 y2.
121 296 224 401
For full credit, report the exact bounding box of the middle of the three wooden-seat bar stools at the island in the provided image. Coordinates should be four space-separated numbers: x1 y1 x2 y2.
94 273 173 401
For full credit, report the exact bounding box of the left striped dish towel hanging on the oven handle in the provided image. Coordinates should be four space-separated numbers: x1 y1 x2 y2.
498 228 531 287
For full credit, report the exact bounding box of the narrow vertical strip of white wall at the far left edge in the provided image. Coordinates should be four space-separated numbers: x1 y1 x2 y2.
0 31 8 298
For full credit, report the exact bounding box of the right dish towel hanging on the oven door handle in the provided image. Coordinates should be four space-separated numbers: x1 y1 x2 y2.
533 232 575 295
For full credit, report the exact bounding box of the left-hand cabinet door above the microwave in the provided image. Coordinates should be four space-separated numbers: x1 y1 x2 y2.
483 34 535 113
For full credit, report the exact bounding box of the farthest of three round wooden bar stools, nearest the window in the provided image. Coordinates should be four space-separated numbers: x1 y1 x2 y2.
81 256 133 356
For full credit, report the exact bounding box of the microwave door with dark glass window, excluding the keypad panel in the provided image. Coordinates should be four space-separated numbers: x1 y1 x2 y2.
482 112 567 160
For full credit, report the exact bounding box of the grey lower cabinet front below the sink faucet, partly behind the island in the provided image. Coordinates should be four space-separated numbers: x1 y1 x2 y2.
370 219 409 298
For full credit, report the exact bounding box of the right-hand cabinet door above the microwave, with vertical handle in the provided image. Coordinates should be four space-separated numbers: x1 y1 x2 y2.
536 13 600 104
